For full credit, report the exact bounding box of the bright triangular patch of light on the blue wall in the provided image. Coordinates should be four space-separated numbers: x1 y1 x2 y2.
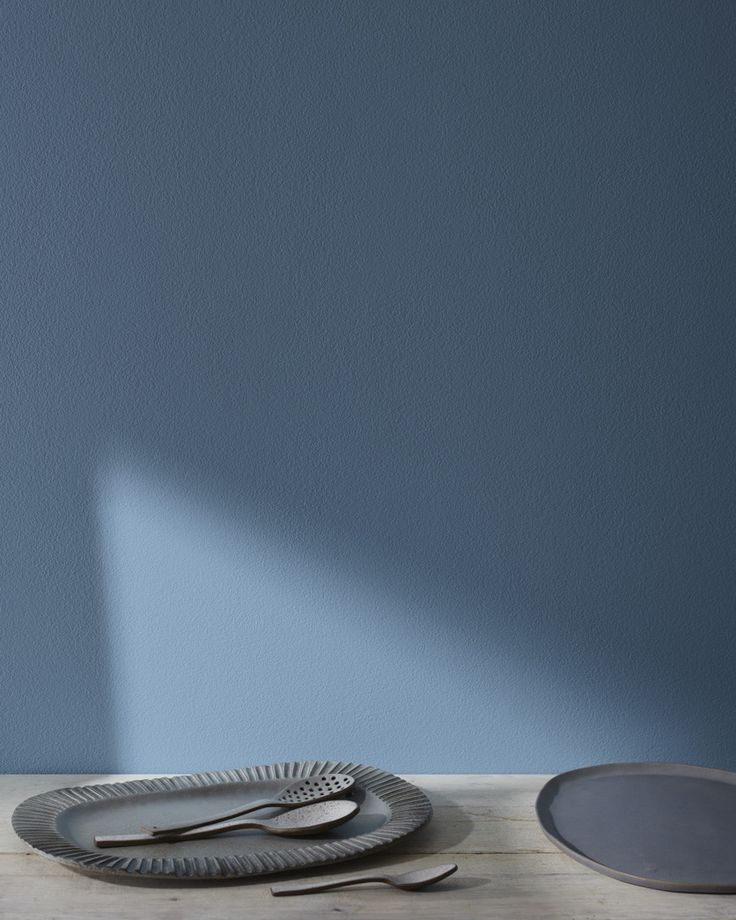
97 454 688 773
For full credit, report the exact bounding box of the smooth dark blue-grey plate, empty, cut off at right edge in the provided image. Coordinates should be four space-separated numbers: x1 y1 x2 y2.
537 763 736 894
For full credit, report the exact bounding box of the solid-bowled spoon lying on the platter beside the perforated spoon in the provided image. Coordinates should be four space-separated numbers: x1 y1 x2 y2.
95 802 359 847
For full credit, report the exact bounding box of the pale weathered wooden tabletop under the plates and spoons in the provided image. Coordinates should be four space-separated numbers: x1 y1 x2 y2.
0 774 736 920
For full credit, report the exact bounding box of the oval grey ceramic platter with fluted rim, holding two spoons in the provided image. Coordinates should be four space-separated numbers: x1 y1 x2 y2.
13 761 432 880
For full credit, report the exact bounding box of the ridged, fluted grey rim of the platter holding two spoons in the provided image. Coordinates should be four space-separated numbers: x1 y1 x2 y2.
12 760 432 880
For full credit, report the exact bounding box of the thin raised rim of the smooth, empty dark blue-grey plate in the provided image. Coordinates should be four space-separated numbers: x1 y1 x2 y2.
534 760 736 894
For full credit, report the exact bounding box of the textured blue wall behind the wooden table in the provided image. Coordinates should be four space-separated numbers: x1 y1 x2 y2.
0 0 736 771
